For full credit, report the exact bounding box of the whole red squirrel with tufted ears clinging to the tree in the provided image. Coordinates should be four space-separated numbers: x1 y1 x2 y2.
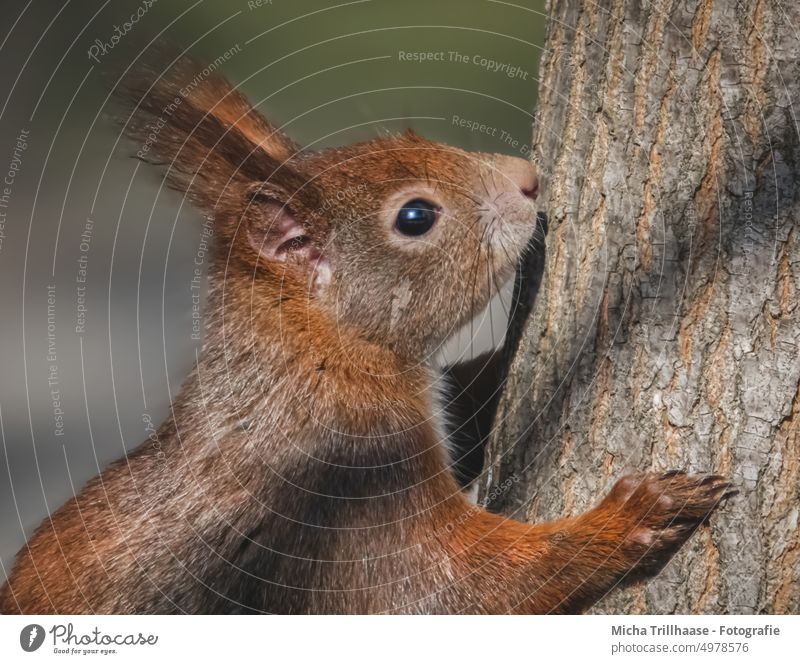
0 56 730 614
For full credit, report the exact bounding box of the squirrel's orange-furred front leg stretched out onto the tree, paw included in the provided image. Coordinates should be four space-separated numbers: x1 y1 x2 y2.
440 471 733 613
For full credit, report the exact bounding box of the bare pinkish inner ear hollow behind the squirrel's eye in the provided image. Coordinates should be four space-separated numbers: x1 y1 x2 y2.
245 191 331 290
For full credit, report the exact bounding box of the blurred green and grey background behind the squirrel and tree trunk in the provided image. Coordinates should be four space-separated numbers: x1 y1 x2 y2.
0 0 545 577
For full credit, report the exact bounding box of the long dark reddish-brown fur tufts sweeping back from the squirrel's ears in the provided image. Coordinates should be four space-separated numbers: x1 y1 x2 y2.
114 45 299 214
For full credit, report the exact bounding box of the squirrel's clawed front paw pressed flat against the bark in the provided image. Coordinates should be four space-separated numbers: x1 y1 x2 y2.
598 470 736 577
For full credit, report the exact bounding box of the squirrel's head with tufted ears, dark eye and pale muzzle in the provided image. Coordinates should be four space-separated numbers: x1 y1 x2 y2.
118 55 538 359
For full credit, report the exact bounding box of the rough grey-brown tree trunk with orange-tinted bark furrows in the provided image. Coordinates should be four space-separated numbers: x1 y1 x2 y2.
483 0 800 613
